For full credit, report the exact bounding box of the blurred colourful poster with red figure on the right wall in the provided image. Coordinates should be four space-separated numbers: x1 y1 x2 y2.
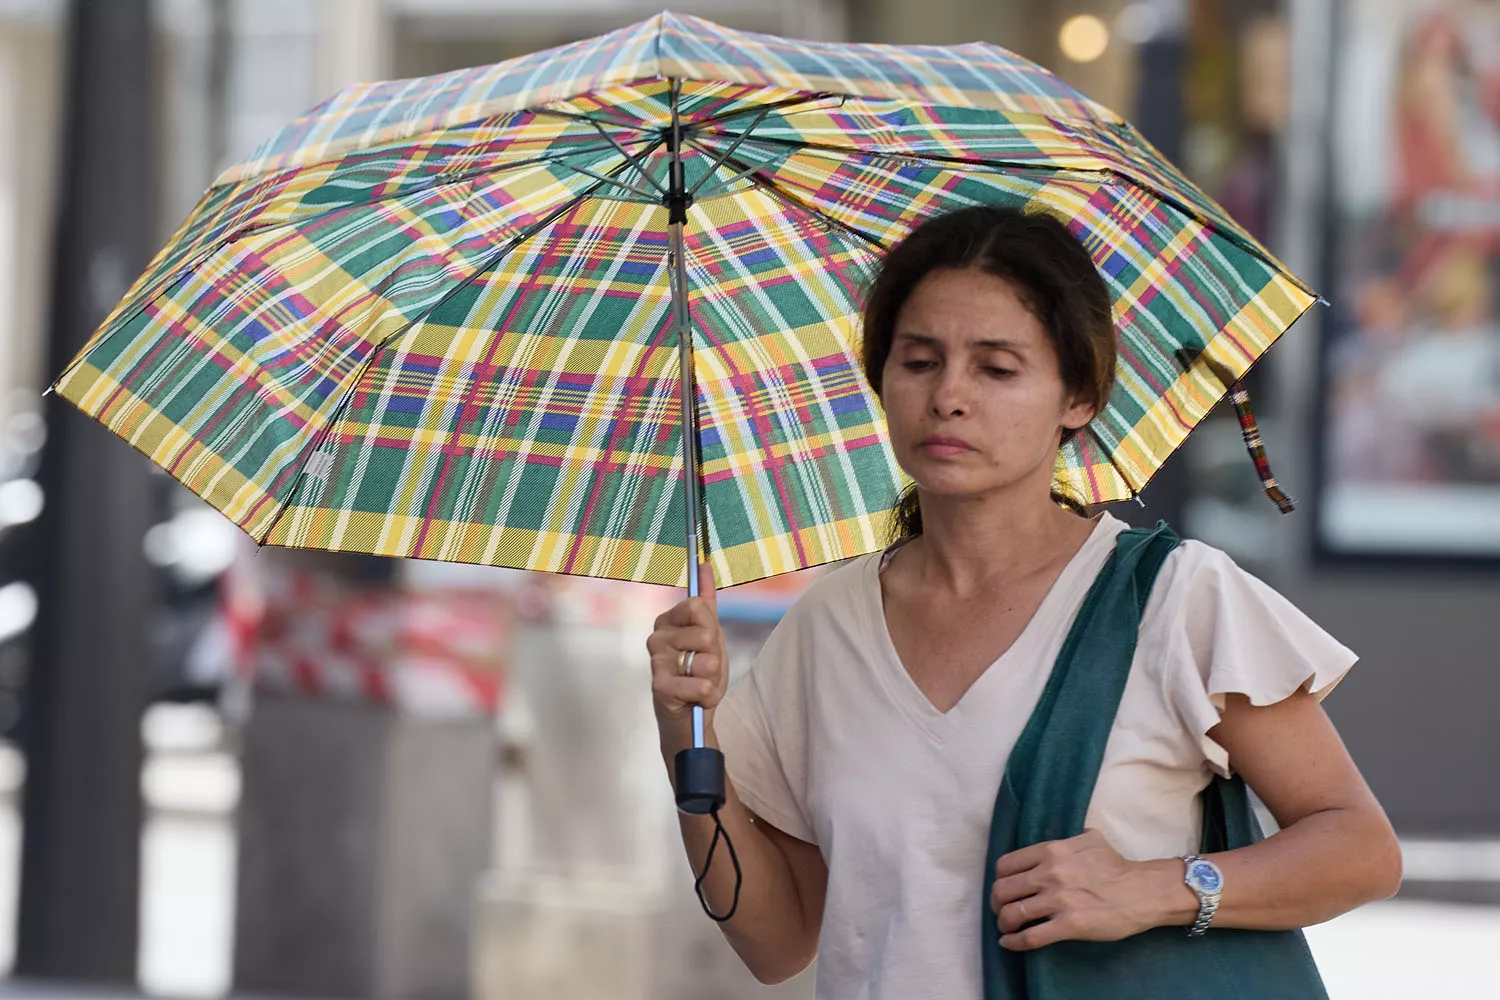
1319 0 1500 558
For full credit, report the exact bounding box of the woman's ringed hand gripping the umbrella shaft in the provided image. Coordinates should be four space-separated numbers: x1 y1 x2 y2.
647 562 729 739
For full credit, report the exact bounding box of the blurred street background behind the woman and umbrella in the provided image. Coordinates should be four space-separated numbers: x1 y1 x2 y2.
0 0 1500 1000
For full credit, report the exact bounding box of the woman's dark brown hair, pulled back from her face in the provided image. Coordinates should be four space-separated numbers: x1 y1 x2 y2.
861 205 1115 538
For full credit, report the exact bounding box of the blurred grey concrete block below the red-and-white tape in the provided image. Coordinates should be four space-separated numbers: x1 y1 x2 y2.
234 691 494 1000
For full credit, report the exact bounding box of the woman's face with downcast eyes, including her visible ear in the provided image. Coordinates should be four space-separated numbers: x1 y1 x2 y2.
881 268 1094 496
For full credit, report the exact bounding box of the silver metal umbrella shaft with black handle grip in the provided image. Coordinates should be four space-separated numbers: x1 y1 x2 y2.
663 79 726 814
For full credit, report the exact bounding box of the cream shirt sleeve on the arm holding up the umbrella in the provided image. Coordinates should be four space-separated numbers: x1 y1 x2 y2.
714 606 816 843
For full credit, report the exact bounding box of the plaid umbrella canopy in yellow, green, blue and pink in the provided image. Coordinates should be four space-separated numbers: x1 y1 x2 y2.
56 13 1316 586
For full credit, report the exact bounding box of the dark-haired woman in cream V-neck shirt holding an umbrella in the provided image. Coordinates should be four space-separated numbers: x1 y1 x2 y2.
647 207 1400 1000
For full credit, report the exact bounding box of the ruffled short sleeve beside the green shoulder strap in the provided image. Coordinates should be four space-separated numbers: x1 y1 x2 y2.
1148 541 1358 775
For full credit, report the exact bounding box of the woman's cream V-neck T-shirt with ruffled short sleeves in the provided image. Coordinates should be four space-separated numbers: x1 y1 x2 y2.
714 513 1355 1000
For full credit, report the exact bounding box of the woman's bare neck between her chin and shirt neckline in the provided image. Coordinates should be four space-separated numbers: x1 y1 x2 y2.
903 485 1094 600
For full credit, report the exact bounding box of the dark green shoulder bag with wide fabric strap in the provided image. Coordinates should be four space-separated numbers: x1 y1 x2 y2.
980 525 1328 1000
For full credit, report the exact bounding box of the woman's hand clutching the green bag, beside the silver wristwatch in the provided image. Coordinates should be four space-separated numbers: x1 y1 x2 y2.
990 831 1197 951
